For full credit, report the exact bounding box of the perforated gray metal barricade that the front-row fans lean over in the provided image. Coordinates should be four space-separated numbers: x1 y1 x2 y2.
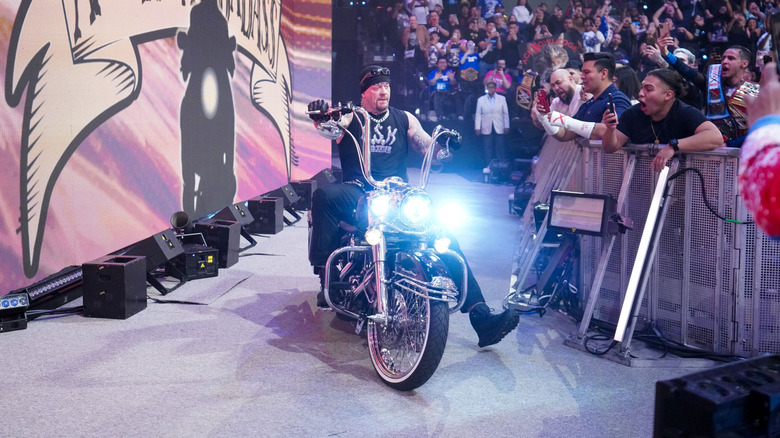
580 142 780 357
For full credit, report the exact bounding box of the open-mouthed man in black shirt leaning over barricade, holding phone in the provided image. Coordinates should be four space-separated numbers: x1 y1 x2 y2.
602 69 723 172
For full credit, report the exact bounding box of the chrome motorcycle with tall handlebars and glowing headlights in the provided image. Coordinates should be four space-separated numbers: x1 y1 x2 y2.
310 104 468 391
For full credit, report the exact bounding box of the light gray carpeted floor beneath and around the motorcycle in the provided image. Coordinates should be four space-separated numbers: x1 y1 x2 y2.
0 174 708 437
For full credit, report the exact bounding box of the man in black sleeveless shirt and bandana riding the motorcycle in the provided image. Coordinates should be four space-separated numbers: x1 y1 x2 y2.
309 65 519 347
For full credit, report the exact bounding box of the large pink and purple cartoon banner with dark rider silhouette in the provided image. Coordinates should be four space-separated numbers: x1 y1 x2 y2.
0 0 330 294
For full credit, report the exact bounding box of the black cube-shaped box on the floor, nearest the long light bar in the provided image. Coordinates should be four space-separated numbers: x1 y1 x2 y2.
82 255 147 319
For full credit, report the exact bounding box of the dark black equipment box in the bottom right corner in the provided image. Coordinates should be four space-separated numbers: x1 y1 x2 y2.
653 355 780 437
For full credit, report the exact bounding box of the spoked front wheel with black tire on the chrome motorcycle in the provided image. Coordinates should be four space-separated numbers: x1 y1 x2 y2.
367 280 450 391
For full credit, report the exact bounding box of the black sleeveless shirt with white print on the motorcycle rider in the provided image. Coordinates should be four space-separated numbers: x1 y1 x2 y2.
339 107 409 184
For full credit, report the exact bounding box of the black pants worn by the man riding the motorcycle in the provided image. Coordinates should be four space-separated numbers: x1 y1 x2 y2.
309 184 485 313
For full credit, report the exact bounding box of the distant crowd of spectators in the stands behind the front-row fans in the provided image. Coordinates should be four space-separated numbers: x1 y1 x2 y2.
380 0 778 126
